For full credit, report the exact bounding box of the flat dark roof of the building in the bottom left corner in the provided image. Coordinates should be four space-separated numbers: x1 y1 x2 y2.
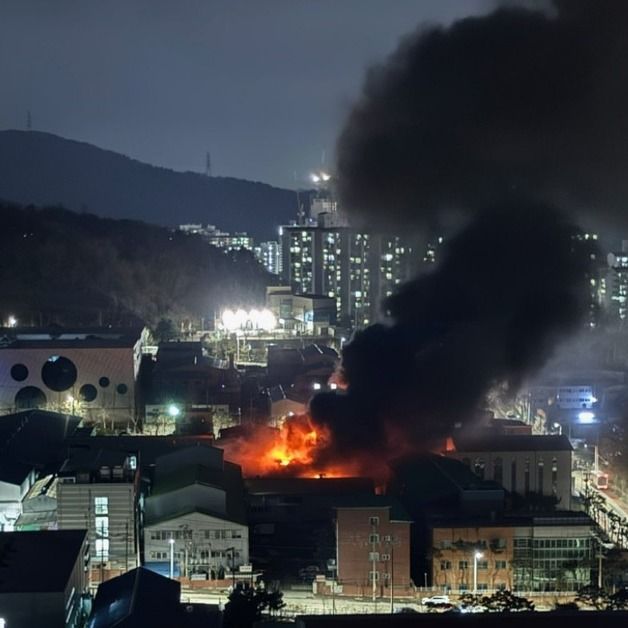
0 530 87 594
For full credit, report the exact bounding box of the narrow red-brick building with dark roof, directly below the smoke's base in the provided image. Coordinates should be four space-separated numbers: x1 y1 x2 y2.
336 495 412 597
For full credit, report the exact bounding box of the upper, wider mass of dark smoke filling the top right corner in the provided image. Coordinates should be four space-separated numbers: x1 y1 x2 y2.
337 0 628 231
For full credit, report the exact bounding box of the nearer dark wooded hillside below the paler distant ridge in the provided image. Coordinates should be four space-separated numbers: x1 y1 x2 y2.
0 203 271 327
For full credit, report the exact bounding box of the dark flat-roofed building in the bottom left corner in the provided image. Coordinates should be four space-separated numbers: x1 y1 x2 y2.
0 530 89 628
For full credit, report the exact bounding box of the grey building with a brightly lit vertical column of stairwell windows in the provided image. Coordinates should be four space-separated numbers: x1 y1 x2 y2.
57 449 139 583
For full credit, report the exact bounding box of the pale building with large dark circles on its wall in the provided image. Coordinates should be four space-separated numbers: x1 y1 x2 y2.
0 328 148 424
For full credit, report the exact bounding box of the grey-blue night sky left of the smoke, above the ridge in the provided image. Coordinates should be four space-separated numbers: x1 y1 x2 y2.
0 0 495 187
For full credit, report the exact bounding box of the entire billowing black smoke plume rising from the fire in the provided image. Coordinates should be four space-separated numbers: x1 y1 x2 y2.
311 0 628 462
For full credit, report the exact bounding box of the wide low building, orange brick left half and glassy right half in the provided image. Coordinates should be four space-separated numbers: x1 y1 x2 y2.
431 512 595 593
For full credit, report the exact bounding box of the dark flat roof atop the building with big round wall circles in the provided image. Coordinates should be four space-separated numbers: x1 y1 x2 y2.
0 327 143 349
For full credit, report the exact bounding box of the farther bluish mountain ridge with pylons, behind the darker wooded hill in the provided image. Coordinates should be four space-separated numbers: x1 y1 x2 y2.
0 131 296 238
